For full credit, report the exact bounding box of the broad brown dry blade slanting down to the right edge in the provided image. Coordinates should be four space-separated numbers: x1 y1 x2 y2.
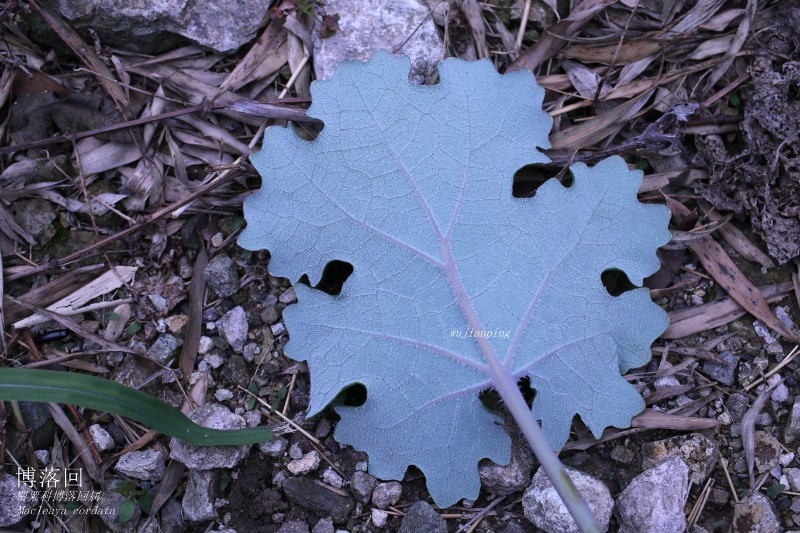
691 236 800 342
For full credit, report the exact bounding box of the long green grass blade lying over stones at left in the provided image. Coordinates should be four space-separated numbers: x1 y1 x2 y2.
0 368 272 446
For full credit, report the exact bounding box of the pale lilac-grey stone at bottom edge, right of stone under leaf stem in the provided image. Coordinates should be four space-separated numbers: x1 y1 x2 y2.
616 457 689 533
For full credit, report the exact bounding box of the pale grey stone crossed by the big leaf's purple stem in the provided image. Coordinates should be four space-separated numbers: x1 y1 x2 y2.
522 467 614 533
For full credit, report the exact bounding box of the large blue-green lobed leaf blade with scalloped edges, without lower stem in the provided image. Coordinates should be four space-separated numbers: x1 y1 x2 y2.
239 53 670 506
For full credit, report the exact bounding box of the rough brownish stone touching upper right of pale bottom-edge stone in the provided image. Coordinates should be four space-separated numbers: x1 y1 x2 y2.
642 433 719 485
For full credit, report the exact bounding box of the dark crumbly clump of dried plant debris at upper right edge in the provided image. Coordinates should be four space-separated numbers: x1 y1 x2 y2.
697 3 800 264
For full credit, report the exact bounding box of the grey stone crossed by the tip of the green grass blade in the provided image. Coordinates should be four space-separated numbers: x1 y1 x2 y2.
169 403 250 469
